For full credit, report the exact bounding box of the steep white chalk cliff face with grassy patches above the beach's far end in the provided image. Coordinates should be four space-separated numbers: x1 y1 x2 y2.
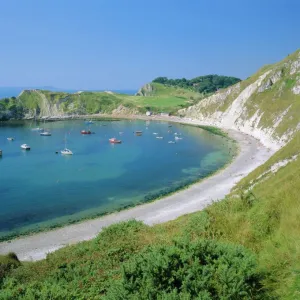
179 50 300 150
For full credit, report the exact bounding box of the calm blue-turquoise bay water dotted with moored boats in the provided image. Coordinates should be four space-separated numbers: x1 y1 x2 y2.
0 120 232 238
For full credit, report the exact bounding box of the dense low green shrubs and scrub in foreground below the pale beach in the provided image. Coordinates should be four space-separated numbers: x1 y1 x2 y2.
0 219 265 299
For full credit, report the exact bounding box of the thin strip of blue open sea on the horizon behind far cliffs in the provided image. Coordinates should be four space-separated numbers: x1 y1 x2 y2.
0 86 137 99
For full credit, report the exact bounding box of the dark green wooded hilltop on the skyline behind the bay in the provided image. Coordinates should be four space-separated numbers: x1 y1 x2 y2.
153 75 241 94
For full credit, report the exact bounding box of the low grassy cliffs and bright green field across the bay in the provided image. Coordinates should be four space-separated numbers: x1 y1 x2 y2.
0 83 203 120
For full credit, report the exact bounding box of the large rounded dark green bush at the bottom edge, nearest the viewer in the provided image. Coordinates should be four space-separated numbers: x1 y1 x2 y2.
107 240 264 300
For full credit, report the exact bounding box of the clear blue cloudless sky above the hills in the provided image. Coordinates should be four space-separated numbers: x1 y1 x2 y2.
0 0 300 90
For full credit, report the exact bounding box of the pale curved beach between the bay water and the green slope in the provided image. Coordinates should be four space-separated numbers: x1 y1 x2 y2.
0 119 274 260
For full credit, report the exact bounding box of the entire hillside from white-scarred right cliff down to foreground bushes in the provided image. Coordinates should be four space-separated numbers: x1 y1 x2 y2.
0 50 300 299
